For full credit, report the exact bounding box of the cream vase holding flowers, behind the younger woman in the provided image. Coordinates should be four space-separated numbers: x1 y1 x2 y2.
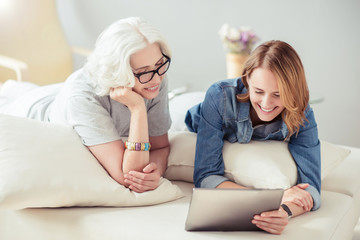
226 53 249 78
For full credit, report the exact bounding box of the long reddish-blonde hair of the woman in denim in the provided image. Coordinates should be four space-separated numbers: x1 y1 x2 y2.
236 41 309 139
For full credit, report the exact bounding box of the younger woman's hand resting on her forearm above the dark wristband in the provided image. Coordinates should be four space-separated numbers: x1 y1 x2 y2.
281 183 314 212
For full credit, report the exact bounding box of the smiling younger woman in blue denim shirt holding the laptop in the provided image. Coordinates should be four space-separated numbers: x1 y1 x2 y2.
185 41 321 234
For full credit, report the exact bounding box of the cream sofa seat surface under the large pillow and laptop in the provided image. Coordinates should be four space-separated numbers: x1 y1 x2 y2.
0 182 355 240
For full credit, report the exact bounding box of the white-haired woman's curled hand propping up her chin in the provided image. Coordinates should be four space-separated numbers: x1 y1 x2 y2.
110 87 145 111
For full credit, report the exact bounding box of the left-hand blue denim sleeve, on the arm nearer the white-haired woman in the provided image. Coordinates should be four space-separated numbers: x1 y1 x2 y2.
185 85 228 187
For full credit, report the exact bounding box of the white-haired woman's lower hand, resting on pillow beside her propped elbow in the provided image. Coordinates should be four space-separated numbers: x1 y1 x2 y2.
124 162 161 193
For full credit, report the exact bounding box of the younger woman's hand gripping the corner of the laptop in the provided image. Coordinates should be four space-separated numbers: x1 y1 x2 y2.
252 207 289 234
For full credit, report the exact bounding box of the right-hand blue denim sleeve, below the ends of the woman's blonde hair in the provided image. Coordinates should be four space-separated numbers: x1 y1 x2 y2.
289 106 321 210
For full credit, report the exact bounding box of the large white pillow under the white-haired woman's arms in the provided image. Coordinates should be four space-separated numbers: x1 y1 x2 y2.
0 115 183 209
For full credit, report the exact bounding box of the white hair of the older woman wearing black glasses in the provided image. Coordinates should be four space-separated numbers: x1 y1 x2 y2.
84 17 171 96
